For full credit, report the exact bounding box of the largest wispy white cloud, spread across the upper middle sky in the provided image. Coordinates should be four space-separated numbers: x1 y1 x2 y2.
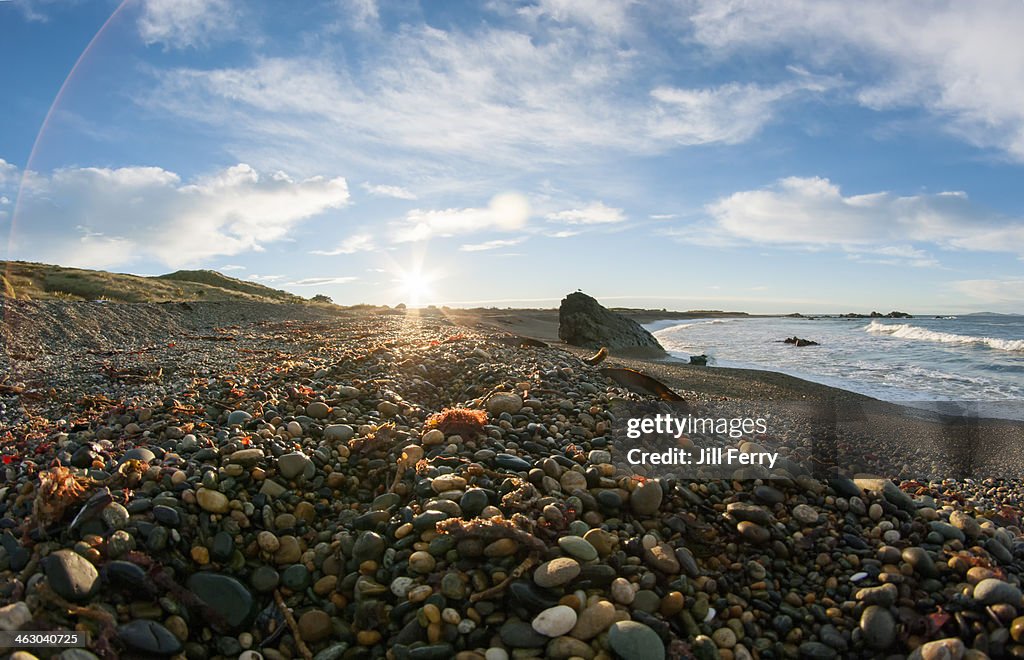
143 17 834 173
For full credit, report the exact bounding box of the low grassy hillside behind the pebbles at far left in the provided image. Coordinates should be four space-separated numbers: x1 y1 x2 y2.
0 261 308 303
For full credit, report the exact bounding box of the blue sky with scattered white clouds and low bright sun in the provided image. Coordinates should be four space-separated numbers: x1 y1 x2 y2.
0 0 1024 313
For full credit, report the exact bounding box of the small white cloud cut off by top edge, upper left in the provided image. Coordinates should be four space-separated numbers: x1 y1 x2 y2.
138 0 239 48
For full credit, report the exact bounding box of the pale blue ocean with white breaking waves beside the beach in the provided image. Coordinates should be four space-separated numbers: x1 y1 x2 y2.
645 314 1024 407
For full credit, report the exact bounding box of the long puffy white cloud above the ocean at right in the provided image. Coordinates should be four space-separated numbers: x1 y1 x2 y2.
704 177 1024 259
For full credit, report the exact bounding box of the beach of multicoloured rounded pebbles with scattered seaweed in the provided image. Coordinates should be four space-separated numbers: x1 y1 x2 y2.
0 301 1024 660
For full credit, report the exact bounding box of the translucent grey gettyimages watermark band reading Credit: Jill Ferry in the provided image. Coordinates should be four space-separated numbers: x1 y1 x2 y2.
611 399 1024 480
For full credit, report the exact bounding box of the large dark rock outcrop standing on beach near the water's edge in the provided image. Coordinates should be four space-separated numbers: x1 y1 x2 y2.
558 292 665 354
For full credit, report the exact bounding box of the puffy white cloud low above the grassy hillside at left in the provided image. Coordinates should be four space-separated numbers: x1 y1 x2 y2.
10 164 349 267
